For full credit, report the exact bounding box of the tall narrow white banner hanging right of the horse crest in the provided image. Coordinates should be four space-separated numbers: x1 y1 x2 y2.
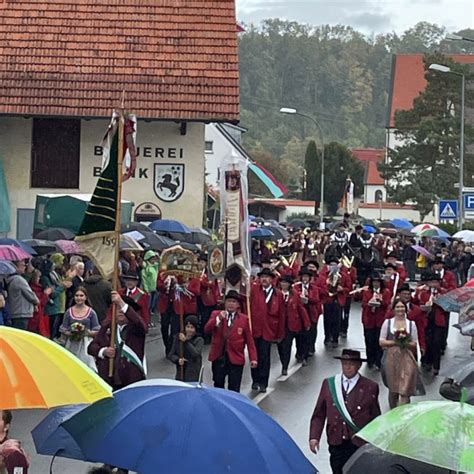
220 150 251 288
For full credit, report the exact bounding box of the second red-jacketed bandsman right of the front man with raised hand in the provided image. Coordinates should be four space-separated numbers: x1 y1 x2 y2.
278 275 311 375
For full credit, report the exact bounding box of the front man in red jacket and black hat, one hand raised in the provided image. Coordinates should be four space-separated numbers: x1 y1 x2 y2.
204 290 257 392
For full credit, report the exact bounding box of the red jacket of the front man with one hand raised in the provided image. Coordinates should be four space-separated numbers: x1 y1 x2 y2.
204 311 257 365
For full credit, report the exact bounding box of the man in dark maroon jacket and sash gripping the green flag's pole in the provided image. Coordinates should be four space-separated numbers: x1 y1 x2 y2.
87 291 147 390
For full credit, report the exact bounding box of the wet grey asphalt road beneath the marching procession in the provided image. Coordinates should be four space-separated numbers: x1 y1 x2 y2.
11 303 470 474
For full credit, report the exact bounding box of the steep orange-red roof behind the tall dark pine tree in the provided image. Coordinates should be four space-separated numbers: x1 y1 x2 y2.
389 54 474 128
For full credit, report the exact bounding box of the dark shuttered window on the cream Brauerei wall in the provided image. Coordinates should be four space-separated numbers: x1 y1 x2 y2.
31 119 81 189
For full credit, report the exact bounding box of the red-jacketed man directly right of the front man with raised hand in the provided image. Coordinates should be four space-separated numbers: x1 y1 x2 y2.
250 268 285 393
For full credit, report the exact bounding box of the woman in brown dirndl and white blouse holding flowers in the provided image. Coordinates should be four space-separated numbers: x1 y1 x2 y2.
379 300 424 408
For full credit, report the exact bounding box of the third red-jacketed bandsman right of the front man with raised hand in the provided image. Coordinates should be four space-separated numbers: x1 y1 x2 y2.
294 267 321 365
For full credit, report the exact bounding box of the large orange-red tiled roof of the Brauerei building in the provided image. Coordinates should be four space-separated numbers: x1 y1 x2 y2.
0 0 239 122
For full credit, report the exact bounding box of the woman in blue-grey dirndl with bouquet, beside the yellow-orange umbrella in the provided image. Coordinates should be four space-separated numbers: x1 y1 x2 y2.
60 286 100 371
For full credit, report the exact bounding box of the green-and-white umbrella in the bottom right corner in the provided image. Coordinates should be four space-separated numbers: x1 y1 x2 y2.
357 394 474 472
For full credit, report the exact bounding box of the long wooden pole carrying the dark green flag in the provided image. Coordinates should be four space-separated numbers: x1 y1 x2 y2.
109 96 125 377
